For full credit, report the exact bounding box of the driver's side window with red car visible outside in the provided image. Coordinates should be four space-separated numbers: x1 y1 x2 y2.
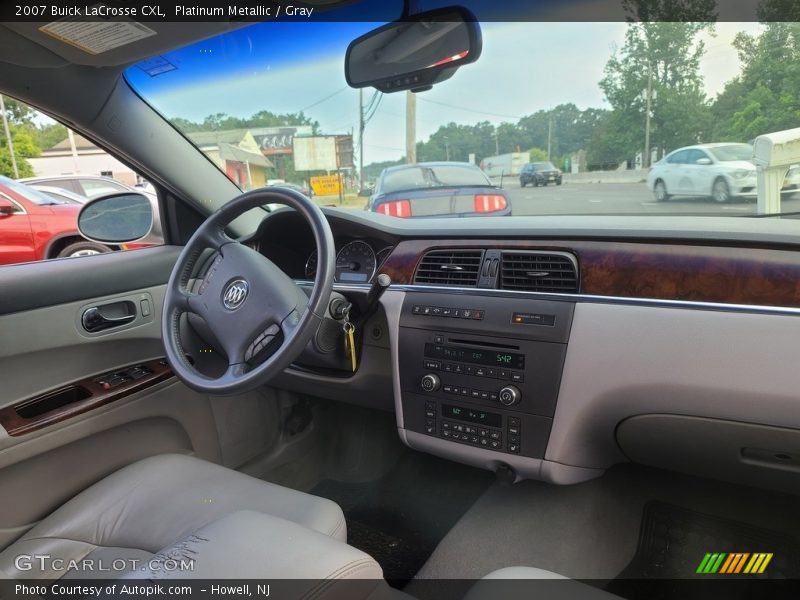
0 96 164 267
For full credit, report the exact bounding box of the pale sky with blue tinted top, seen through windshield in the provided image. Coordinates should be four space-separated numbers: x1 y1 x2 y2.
127 22 761 164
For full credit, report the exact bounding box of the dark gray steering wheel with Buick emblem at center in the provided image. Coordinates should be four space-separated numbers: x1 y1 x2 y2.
161 189 336 394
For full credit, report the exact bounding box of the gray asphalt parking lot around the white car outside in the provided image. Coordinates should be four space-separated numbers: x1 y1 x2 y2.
503 180 800 216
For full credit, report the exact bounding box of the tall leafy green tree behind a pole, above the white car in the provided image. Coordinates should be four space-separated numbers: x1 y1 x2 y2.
590 21 713 162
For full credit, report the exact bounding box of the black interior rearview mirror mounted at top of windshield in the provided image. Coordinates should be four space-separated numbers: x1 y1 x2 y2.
345 6 482 93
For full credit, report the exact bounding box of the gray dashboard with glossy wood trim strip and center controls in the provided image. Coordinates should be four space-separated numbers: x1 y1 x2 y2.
251 211 800 489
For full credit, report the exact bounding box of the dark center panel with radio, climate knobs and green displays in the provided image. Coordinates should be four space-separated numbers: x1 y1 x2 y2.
398 293 574 464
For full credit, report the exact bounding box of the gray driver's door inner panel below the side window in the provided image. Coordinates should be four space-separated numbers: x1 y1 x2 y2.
0 247 222 549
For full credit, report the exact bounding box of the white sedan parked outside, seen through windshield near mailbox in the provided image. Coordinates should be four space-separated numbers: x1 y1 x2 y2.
647 143 757 202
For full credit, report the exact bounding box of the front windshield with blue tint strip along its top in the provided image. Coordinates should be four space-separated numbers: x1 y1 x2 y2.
125 15 800 218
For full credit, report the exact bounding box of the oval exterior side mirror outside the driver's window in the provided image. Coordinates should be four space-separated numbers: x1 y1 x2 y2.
78 192 153 244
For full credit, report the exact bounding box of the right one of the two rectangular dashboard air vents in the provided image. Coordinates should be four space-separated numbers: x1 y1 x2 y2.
500 251 578 294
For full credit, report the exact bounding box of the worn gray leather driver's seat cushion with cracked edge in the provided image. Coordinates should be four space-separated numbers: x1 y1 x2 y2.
0 455 368 580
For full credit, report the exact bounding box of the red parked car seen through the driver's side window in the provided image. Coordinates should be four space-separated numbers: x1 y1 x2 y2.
0 176 113 265
